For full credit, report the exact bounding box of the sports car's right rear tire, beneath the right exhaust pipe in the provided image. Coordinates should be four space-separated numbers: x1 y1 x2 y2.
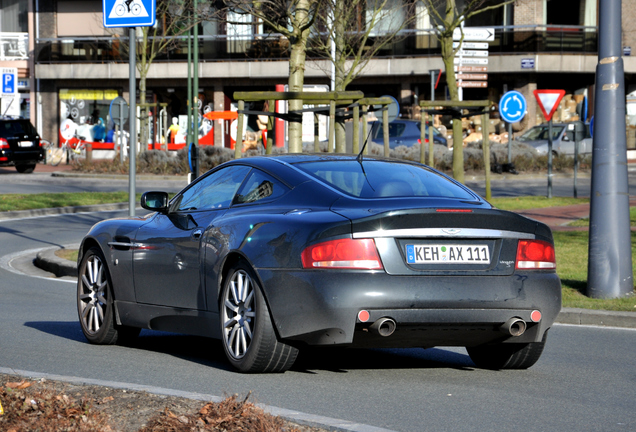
466 331 548 370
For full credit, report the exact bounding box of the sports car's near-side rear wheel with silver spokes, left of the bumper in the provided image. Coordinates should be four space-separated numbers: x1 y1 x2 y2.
220 262 298 373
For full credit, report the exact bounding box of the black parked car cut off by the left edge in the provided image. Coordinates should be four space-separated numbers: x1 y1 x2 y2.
0 117 44 173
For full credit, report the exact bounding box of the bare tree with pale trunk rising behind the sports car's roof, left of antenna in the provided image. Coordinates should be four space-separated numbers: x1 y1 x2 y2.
225 0 323 153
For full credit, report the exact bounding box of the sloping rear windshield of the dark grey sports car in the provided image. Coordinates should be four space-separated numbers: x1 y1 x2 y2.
295 159 476 200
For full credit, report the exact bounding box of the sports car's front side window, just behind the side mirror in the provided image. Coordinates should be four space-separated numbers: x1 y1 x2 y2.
173 165 250 211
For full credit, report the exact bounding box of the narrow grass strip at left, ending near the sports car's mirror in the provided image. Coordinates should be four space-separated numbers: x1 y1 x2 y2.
0 192 141 211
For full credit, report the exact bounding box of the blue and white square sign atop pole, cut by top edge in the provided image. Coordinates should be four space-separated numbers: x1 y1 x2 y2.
103 0 157 27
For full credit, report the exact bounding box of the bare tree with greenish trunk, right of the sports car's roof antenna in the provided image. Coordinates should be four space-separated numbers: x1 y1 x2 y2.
420 0 516 183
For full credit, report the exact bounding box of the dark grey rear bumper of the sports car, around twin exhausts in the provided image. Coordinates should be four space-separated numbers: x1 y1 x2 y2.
258 269 561 347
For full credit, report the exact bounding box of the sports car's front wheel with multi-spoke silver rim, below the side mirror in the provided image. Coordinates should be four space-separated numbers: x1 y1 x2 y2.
77 247 140 345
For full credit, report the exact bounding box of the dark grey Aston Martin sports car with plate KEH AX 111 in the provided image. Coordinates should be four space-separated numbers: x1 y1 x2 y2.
77 154 561 372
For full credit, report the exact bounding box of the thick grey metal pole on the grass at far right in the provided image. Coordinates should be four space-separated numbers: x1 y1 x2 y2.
586 0 634 298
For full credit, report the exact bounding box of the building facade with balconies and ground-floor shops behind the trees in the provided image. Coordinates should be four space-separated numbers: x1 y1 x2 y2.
0 0 636 146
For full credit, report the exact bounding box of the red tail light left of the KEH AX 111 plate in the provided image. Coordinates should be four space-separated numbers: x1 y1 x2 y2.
301 239 383 270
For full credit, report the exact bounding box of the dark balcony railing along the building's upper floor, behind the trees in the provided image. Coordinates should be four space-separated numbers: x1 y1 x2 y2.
36 26 598 63
